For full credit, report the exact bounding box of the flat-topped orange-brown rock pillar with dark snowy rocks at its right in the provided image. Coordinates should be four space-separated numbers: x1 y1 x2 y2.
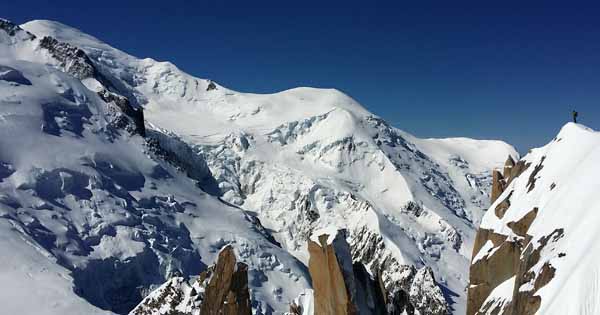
304 230 448 315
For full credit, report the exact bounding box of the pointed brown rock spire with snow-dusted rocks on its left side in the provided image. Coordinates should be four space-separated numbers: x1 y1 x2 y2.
130 246 252 315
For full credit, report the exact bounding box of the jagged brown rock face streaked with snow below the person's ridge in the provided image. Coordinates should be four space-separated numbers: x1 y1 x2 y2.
467 156 563 315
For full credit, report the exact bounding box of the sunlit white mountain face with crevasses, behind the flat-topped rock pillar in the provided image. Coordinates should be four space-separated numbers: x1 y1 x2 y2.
18 21 517 314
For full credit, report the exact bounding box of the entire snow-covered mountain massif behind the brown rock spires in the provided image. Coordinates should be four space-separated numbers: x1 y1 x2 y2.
0 21 517 314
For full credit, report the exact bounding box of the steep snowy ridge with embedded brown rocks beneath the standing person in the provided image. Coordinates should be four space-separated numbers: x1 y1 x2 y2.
470 123 600 315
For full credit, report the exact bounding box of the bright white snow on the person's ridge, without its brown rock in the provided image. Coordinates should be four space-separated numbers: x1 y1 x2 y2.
474 123 600 315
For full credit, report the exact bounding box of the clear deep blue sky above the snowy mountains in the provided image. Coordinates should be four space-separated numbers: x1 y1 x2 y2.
1 0 600 152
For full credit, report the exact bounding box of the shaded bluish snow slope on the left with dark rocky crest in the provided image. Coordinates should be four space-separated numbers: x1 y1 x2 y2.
0 21 310 314
